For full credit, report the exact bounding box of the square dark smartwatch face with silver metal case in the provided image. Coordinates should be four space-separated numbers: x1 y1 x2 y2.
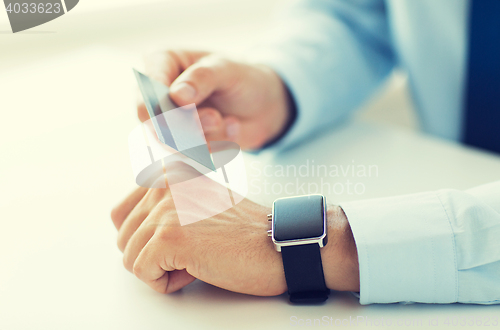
273 195 325 242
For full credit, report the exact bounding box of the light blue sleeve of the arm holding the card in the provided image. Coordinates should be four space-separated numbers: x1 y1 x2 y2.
248 0 394 149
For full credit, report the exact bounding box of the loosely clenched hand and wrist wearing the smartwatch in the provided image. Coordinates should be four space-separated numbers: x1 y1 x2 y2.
111 164 359 296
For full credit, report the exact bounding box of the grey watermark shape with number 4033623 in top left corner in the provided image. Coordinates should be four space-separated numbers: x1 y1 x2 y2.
4 0 79 33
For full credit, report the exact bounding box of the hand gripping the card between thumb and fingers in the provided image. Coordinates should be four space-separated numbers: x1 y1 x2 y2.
138 51 290 149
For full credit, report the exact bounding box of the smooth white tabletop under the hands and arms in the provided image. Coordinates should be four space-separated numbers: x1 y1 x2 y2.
0 48 500 330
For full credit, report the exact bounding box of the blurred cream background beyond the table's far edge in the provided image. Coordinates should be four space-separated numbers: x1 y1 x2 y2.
0 0 417 129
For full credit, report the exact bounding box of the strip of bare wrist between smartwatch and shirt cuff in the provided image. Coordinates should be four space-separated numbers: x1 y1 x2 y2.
321 205 359 292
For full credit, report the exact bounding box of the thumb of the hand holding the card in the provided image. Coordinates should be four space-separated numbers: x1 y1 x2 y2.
170 56 235 106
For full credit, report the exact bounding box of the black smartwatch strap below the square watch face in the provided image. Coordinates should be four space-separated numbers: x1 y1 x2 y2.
281 243 330 304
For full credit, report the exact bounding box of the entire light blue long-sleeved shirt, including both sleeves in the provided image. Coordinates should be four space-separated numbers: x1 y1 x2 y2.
252 0 500 304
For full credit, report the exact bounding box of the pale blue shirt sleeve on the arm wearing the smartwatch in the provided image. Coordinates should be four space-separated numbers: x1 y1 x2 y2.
341 181 500 304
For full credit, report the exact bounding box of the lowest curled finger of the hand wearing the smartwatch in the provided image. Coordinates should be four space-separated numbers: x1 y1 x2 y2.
133 240 196 293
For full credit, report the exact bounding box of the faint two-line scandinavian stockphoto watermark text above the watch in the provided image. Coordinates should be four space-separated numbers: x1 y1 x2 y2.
249 159 379 196
